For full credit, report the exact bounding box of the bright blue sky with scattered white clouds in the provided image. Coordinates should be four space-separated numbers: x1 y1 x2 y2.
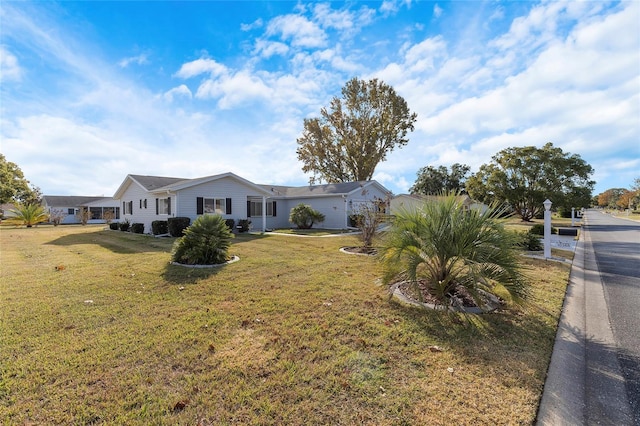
0 0 640 196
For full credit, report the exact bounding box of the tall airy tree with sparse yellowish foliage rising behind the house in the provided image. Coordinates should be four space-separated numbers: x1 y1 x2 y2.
296 78 417 183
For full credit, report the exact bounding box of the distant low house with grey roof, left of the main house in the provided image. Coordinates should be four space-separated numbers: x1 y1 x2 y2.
42 195 120 224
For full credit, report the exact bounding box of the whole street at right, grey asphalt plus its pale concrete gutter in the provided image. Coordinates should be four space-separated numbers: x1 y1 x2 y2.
537 210 640 426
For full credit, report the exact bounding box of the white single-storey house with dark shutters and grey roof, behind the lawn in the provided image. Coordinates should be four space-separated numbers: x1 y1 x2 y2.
113 173 391 233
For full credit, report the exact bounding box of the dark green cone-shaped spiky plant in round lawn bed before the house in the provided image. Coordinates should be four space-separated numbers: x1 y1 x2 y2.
172 215 233 265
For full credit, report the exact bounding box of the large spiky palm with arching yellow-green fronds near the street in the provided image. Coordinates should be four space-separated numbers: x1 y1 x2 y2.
381 193 528 309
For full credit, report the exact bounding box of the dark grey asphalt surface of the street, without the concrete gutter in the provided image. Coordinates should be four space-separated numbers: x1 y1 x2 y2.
585 210 640 425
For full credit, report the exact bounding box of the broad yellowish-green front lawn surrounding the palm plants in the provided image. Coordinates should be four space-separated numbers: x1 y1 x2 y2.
0 226 569 425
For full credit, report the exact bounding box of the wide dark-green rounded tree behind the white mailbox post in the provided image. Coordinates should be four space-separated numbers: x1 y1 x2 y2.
466 143 595 221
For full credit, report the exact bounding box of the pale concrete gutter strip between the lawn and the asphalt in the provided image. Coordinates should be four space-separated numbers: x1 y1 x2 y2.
537 218 633 426
